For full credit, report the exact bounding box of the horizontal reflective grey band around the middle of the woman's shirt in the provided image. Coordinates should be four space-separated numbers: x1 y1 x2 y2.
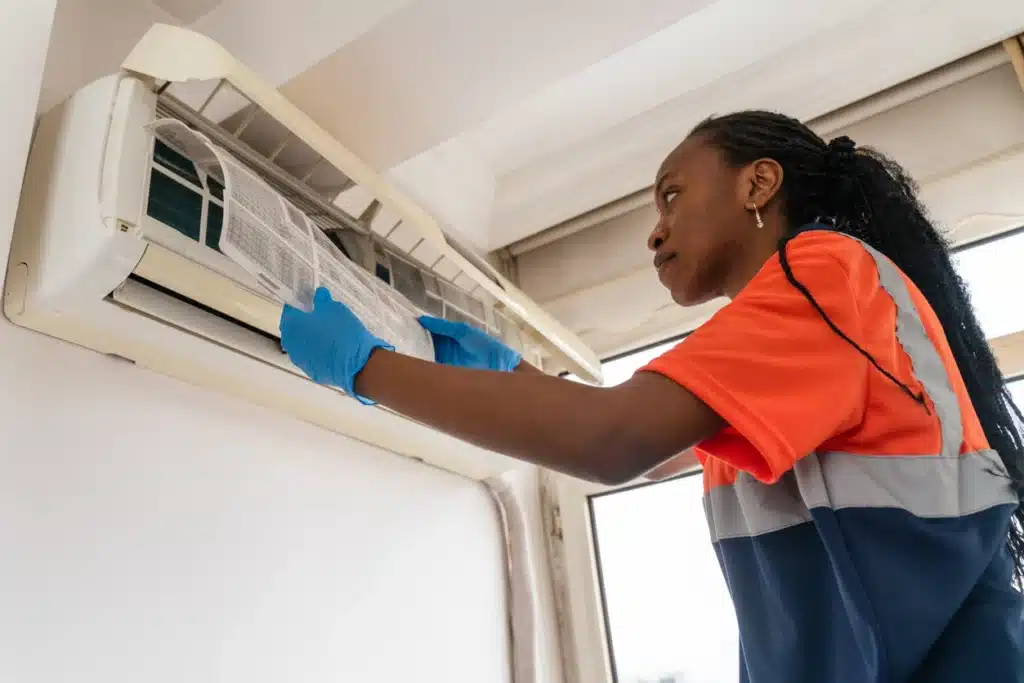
705 451 1017 541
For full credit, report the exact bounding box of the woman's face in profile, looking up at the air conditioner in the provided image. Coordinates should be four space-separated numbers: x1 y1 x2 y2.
647 134 754 306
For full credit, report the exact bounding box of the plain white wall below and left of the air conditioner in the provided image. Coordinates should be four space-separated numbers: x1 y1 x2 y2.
0 0 524 683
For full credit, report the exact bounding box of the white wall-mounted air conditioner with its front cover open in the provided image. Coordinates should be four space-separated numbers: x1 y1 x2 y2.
4 25 600 478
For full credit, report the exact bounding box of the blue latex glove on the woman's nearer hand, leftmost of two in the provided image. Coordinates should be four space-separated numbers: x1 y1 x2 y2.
281 287 394 405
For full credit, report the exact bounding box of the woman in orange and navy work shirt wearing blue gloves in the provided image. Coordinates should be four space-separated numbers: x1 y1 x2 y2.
282 112 1024 683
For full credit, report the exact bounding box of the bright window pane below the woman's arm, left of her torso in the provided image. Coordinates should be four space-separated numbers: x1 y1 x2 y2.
591 474 739 683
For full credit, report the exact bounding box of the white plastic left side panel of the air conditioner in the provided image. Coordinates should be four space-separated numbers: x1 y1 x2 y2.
4 76 148 327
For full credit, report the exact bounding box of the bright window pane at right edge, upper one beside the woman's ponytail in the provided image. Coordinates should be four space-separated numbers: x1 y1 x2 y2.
954 231 1024 339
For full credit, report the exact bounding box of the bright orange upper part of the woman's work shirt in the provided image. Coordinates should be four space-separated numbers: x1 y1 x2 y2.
642 230 988 490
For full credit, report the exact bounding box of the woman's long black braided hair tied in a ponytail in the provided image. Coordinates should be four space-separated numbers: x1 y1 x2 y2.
693 112 1024 586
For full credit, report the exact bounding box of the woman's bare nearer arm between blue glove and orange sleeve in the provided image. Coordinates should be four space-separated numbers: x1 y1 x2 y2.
354 349 725 484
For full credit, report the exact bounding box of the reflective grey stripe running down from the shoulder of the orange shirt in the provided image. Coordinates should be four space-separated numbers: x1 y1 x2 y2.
847 236 964 458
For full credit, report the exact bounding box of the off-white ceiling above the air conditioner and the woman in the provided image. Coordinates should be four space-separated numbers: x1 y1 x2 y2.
42 0 1024 362
